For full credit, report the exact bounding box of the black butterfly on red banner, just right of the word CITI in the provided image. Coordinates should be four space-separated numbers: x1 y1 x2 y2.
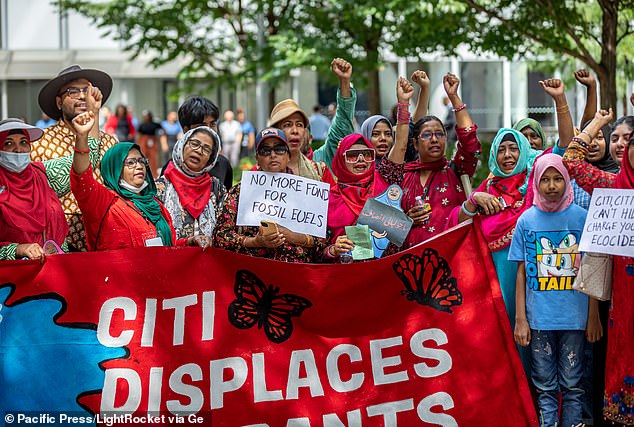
229 270 312 344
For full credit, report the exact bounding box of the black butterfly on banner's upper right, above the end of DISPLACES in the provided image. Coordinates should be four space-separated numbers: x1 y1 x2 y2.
392 248 462 313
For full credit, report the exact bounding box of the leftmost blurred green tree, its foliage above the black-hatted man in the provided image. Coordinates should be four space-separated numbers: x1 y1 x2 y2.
60 0 298 106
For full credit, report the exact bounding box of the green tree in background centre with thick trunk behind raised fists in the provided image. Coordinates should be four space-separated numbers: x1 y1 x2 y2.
270 0 467 114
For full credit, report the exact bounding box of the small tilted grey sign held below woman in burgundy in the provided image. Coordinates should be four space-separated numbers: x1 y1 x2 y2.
357 199 414 246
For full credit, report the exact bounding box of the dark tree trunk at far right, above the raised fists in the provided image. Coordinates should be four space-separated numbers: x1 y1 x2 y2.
598 0 619 110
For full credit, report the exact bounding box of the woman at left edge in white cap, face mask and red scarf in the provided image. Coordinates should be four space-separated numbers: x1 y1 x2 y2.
0 119 68 259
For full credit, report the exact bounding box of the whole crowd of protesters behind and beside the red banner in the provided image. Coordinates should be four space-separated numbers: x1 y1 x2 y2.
0 58 634 427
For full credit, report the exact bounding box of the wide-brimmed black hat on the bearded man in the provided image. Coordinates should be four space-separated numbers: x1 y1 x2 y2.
37 65 112 120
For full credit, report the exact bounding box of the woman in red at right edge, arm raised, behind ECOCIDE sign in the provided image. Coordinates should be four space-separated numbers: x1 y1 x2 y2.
563 109 634 426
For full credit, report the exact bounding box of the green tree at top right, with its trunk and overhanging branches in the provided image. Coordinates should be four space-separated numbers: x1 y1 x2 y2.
454 0 634 108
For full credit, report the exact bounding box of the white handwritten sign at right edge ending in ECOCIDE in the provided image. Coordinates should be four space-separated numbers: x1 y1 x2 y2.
579 188 634 257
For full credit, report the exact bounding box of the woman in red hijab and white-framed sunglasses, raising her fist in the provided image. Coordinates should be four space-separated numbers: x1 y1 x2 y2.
326 77 414 258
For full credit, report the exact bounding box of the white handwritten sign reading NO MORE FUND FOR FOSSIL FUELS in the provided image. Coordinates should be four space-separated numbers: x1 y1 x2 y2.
236 171 330 237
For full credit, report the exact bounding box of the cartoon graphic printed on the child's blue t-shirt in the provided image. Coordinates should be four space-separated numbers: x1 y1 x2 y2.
526 231 581 291
